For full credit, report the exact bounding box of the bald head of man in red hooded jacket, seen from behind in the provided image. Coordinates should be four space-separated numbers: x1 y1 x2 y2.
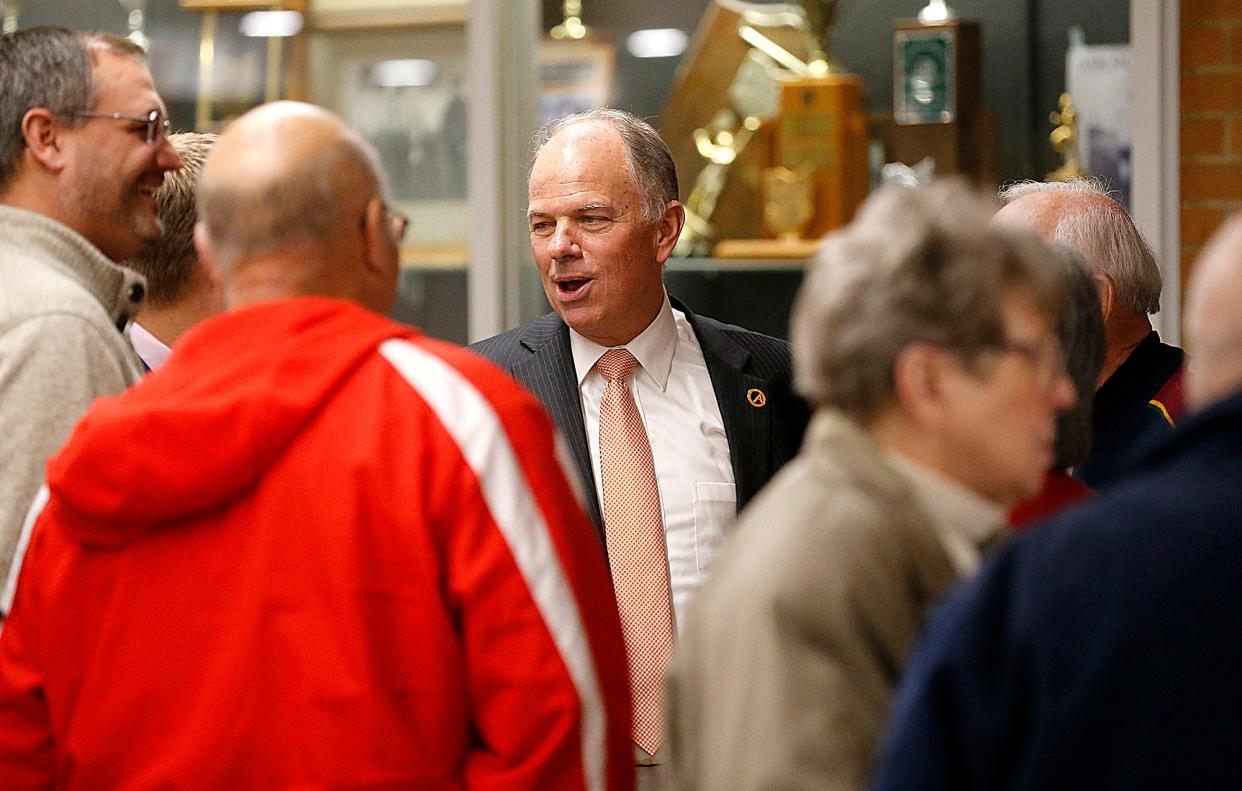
199 102 396 310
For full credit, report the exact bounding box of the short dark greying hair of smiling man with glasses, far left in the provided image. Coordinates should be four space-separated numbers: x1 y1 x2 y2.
0 27 145 191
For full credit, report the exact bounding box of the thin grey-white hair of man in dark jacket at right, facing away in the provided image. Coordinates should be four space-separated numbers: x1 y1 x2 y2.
996 179 1163 315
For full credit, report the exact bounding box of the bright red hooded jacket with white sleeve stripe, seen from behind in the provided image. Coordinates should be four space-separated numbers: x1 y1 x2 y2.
0 298 633 791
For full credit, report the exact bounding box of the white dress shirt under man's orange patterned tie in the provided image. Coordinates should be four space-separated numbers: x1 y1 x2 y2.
569 294 738 632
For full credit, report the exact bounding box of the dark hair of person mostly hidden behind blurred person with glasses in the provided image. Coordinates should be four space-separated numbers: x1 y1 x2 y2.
1048 242 1104 469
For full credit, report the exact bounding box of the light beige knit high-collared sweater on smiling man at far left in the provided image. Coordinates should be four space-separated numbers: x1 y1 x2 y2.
0 206 145 590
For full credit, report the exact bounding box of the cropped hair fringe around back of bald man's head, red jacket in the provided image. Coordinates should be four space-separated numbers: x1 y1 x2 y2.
199 130 386 268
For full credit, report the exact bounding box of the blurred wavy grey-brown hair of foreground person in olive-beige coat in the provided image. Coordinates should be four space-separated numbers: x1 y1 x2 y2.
790 180 1064 423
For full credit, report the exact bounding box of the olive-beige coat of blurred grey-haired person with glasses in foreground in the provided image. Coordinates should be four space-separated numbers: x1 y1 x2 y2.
668 410 993 791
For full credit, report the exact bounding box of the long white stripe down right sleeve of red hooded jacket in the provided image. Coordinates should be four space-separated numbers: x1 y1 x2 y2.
380 340 606 791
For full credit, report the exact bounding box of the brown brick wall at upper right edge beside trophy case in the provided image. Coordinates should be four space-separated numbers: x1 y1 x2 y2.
1180 0 1242 291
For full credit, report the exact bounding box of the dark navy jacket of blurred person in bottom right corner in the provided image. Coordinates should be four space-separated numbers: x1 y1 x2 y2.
876 384 1242 790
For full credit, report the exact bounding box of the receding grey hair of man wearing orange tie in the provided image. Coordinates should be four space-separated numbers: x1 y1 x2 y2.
530 107 677 225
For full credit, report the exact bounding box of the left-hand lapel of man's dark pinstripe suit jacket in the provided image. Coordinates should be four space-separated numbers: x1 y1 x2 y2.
513 314 604 538
